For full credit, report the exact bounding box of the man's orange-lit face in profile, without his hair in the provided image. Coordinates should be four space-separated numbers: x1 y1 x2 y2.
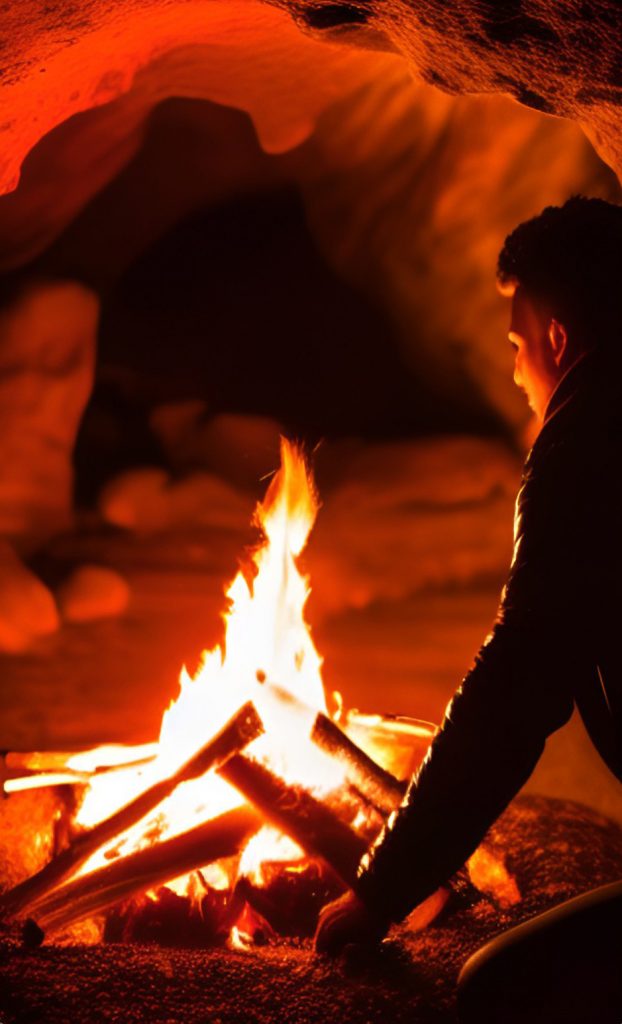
508 285 562 422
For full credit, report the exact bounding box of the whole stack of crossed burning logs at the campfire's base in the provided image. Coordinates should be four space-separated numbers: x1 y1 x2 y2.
0 701 424 944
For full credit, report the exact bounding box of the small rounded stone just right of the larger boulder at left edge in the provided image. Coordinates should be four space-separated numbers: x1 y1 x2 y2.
56 565 130 623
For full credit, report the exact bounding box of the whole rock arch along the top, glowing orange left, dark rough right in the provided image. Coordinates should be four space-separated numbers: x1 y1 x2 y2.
0 0 622 201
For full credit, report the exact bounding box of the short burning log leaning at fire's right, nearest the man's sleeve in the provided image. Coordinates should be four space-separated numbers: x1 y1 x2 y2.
310 712 408 814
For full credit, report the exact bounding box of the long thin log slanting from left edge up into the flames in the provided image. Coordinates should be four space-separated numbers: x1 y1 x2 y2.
0 701 263 918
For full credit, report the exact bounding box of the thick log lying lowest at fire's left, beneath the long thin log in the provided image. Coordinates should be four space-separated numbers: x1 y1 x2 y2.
27 806 262 941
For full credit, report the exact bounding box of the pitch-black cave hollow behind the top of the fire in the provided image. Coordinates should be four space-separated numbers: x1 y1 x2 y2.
71 187 496 499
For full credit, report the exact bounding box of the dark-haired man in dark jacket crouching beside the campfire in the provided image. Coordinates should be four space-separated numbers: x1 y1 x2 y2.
316 197 622 1024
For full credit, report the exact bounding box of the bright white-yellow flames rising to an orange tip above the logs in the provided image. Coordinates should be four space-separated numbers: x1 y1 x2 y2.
78 439 342 891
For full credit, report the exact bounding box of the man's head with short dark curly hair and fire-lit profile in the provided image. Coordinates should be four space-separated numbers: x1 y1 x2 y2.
497 197 622 420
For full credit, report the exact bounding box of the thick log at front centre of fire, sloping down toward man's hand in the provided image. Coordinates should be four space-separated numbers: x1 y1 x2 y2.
218 754 367 888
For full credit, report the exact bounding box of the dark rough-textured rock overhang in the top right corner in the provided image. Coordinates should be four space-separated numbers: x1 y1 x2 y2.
286 0 622 171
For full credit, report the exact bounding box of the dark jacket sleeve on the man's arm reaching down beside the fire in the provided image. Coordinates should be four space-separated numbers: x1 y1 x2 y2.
358 444 587 923
